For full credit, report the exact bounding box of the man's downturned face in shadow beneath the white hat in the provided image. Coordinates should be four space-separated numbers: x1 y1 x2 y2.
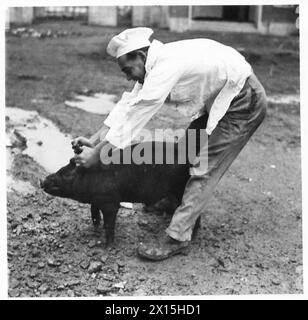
118 52 146 83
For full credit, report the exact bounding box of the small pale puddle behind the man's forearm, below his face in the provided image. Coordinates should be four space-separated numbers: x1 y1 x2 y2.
65 93 116 114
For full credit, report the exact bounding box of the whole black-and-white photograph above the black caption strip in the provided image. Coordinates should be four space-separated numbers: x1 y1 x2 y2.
1 1 304 300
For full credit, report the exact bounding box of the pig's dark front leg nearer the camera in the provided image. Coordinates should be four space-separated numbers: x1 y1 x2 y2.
100 203 120 247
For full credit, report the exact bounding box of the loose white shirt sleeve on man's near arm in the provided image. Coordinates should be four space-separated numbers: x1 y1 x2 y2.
106 59 182 148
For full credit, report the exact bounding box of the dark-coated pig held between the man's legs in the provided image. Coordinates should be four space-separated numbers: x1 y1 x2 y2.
41 141 192 245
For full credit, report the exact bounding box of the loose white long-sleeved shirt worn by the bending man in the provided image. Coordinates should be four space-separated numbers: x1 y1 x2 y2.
104 39 252 148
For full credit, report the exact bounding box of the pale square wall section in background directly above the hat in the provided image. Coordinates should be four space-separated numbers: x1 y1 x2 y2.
88 6 117 26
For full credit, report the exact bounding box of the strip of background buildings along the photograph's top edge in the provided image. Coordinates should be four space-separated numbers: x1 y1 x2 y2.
6 5 298 35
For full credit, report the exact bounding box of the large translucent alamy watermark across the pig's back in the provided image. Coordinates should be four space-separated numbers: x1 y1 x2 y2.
101 129 208 175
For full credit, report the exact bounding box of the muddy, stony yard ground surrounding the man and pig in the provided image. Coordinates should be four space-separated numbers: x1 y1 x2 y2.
6 22 303 297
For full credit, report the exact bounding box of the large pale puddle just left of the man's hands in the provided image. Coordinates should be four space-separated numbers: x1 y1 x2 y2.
6 108 74 172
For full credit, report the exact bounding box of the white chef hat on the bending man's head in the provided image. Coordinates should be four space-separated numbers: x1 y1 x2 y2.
106 27 154 58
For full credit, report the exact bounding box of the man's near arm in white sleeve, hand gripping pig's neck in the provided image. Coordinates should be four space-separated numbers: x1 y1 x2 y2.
75 59 183 167
